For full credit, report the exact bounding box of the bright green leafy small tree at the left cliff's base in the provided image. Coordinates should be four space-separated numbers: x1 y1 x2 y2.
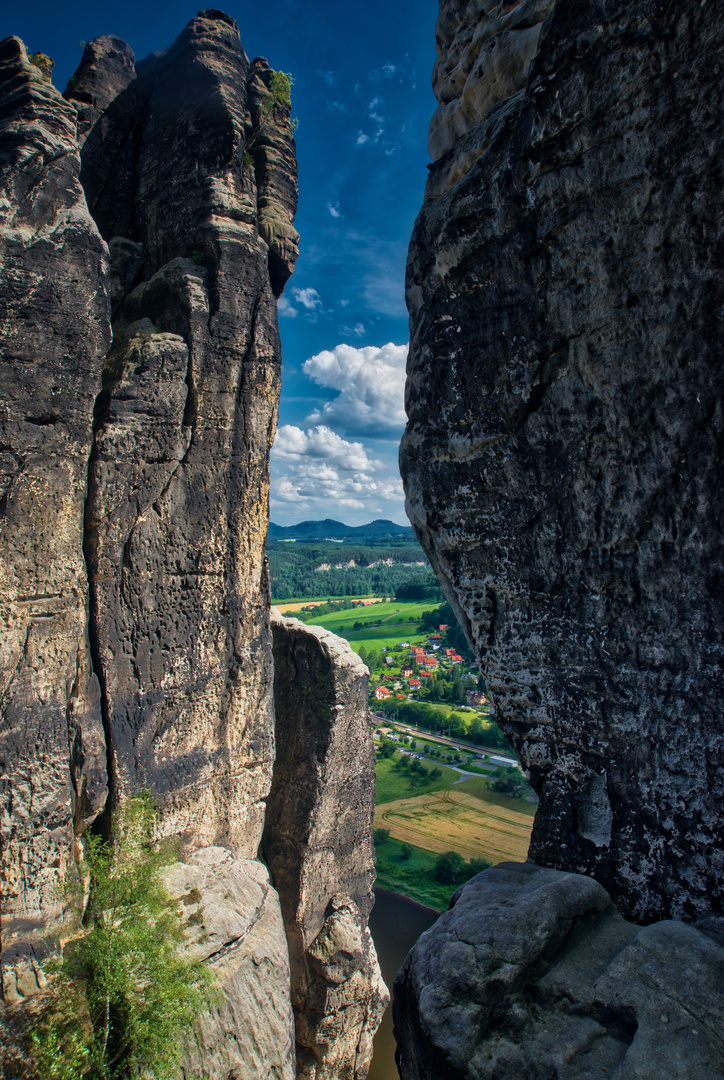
26 797 214 1080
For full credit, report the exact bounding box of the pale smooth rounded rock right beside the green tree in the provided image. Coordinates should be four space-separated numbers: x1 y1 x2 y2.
164 848 295 1080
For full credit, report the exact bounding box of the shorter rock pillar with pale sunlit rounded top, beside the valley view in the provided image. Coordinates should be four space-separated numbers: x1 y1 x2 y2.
263 616 389 1080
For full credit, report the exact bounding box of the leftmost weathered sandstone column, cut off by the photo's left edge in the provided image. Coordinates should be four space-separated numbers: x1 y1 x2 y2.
0 38 110 1001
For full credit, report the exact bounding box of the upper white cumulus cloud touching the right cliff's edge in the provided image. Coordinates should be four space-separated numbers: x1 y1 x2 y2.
303 342 407 434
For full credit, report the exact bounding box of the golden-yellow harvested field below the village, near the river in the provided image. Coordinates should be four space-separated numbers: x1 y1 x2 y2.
375 786 533 863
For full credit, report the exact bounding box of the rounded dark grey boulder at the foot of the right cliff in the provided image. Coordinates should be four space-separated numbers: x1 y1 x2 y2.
393 863 724 1080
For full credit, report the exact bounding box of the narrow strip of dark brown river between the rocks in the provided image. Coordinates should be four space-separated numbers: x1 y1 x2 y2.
367 889 439 1080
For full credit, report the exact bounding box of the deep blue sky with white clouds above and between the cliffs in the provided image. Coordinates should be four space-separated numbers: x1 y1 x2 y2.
0 0 438 525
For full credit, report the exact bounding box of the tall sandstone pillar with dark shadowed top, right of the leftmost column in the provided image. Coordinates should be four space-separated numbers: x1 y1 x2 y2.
79 12 296 858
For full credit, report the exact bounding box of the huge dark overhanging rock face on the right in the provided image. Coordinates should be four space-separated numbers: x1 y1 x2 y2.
401 0 724 922
